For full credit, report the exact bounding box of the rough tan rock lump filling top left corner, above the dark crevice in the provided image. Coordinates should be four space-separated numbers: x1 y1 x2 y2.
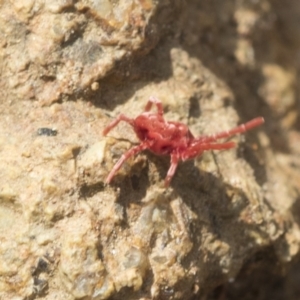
0 0 180 105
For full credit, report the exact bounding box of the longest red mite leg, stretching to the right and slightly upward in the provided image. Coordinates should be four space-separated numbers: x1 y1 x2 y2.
197 117 265 143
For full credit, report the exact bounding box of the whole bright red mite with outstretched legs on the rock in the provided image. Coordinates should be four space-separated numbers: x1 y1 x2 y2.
103 97 264 187
